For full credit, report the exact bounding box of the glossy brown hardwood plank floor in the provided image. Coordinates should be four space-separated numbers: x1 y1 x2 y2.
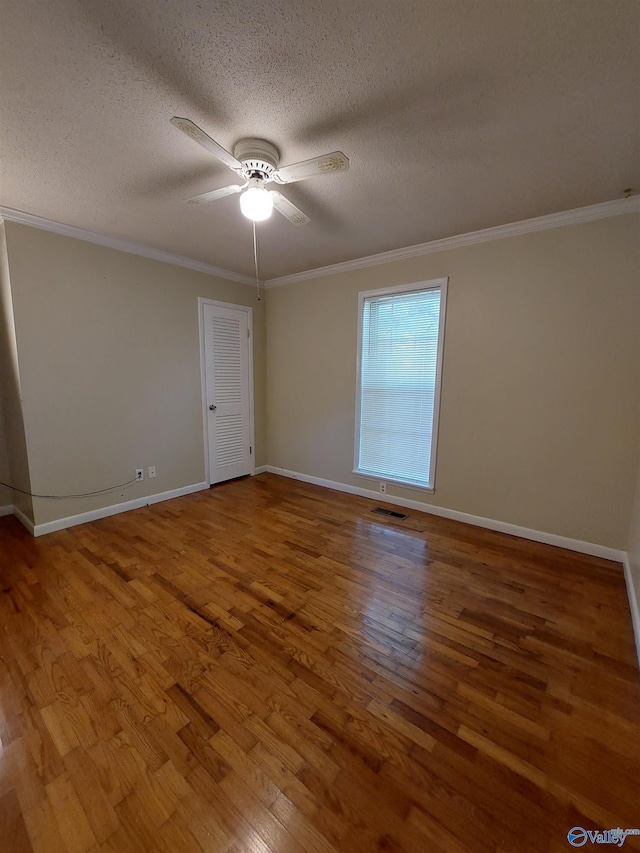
0 474 640 853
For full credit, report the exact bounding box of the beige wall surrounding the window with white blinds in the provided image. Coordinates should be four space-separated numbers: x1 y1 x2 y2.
267 214 640 549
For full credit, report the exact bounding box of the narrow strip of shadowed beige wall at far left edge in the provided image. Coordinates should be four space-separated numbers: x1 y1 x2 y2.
0 221 33 521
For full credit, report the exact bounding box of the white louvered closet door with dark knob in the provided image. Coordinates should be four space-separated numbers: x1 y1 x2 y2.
203 303 253 483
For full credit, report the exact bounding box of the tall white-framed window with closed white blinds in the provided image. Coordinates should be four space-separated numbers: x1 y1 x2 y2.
354 278 447 490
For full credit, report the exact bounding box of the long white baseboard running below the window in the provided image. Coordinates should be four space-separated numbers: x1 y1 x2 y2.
265 465 625 563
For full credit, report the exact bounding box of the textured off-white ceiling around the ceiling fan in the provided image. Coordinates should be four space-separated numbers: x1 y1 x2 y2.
0 0 640 278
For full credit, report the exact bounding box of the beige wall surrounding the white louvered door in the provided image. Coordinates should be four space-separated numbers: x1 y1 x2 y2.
6 222 265 524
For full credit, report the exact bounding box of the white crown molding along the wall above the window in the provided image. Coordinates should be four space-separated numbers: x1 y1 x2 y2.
264 195 640 290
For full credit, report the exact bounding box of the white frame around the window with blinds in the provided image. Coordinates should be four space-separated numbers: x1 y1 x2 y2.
352 277 449 494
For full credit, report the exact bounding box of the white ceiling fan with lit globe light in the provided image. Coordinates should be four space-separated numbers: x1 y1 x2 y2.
171 116 349 225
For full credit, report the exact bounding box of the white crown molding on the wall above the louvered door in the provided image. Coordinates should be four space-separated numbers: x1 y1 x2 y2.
0 205 255 286
